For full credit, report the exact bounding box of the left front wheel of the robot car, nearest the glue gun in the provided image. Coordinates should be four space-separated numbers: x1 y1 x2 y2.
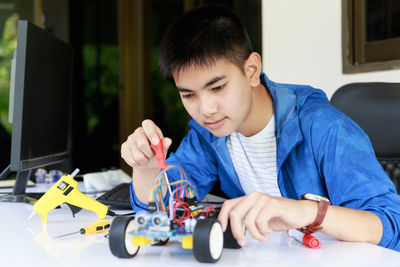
108 216 140 258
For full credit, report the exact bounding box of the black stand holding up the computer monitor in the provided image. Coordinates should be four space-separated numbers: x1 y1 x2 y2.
0 170 37 204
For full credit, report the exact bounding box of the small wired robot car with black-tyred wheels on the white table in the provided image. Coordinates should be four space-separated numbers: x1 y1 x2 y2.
109 165 240 263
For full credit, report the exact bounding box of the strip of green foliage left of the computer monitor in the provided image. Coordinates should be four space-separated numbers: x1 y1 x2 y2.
0 14 19 133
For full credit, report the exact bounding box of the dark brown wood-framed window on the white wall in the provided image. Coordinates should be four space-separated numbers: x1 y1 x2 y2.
342 0 400 73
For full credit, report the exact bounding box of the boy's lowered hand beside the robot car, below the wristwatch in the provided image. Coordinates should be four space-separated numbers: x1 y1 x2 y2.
218 192 318 246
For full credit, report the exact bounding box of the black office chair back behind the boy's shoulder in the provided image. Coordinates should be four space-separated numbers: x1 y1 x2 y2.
330 82 400 192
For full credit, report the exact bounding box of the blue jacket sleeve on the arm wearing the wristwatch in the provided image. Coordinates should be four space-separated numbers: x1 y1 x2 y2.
313 112 400 251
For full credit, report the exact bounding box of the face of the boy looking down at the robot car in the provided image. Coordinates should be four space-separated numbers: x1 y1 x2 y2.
173 59 251 137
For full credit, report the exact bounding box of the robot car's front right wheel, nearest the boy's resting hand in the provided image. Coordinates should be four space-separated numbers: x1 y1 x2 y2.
193 219 224 263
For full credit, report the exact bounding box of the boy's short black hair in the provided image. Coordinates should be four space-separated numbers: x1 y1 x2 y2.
159 5 253 77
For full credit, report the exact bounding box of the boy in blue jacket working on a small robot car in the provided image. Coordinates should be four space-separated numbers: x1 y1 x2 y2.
121 6 400 250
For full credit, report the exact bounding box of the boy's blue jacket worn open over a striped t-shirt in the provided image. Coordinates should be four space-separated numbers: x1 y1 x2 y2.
131 74 400 251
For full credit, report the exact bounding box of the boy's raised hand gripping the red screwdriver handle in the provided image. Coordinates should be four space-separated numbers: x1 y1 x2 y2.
121 120 172 170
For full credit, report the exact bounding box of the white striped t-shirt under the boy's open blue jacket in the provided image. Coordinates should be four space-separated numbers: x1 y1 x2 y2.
227 116 281 197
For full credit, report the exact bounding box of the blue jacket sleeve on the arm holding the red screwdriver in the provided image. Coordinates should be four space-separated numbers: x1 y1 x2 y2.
131 129 217 212
